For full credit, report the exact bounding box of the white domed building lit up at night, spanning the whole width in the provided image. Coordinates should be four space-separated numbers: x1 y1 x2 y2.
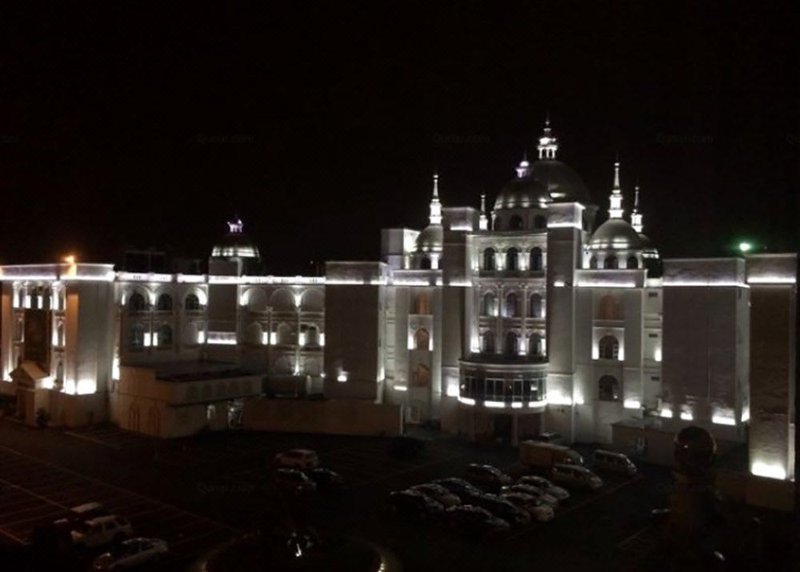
0 120 797 479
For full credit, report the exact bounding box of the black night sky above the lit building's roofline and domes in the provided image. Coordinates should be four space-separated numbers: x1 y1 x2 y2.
0 1 800 274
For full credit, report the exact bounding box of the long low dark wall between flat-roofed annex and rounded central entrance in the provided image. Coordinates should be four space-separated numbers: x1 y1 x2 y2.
242 399 403 436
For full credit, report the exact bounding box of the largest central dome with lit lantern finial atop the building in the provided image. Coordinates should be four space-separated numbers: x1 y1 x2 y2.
492 118 597 230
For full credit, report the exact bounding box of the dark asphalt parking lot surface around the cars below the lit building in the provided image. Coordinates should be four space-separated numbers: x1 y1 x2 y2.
0 418 688 571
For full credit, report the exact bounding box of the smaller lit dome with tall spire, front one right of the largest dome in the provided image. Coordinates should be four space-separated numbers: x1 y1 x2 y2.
586 161 645 269
